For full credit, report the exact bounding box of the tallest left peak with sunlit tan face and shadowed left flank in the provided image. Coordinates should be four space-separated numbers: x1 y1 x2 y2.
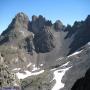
0 12 31 44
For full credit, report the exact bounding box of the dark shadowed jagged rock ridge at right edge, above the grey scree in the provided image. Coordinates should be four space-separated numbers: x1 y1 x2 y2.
65 15 90 54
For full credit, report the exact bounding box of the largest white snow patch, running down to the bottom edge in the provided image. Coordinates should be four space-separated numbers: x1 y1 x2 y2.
52 67 71 90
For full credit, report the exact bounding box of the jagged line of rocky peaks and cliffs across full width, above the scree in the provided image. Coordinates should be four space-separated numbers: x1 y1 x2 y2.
0 12 90 55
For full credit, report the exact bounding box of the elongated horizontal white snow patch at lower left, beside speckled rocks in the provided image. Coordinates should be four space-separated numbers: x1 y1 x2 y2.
16 70 44 79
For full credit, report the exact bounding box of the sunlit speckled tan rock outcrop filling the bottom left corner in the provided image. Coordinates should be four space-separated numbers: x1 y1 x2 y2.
0 53 20 87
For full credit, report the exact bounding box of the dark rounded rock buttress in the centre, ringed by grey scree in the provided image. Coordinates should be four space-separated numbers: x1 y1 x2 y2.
34 26 55 53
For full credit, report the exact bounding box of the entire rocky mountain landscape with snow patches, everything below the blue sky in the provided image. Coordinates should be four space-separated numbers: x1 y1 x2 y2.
0 12 90 90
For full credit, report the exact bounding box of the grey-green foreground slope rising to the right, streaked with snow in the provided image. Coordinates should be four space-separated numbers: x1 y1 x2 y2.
22 42 90 90
